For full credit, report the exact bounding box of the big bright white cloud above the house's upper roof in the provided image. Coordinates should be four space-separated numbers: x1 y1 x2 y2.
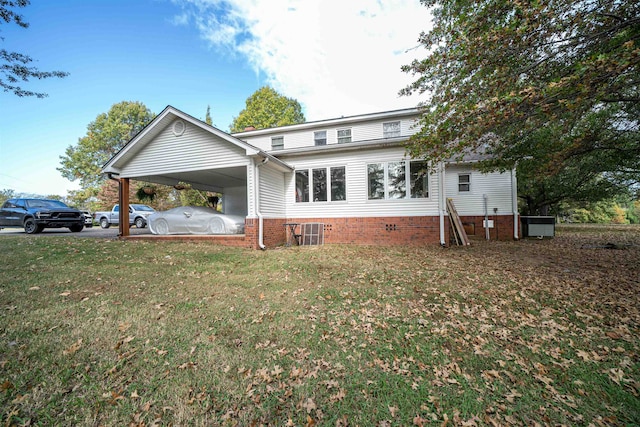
175 0 430 120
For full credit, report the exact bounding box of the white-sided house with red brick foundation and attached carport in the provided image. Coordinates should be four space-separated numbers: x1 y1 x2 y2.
103 106 518 248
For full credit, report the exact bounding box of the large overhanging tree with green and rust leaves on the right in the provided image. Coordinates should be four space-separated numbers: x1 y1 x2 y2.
401 0 640 206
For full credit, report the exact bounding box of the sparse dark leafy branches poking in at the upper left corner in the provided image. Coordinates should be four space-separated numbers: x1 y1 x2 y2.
0 0 69 98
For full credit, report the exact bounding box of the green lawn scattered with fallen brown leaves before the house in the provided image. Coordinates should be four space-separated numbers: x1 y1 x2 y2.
0 226 640 426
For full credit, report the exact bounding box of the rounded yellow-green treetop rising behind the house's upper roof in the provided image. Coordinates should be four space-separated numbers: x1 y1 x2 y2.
230 86 305 132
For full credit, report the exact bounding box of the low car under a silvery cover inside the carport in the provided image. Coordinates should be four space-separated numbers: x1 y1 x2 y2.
147 206 244 234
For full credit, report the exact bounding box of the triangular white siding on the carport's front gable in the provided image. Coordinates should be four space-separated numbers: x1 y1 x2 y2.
120 123 250 178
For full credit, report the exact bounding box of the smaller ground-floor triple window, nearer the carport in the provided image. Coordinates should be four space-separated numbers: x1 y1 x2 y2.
296 166 347 203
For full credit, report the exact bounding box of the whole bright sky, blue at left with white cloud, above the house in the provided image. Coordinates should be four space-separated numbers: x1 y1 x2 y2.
0 0 429 196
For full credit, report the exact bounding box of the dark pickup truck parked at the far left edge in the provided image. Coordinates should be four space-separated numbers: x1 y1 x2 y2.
0 199 84 234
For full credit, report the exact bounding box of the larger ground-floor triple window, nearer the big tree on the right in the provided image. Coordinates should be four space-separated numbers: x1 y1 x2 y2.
367 160 429 200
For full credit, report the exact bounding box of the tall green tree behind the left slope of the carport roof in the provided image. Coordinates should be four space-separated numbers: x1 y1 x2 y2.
57 101 155 196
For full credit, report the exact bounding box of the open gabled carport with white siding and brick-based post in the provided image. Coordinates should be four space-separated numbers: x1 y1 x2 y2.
102 106 293 248
